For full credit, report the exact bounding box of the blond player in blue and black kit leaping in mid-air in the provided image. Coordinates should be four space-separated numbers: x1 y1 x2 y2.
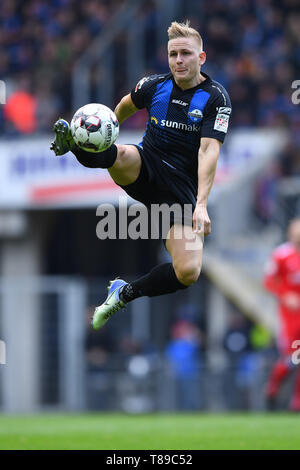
51 22 231 329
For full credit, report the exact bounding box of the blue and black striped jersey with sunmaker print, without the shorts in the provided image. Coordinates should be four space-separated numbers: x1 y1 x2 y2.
131 72 231 184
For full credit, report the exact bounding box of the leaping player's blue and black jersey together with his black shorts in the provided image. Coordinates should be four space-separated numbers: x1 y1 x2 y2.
114 72 231 225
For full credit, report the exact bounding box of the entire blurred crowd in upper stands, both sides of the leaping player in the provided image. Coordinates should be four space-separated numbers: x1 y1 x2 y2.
0 0 300 133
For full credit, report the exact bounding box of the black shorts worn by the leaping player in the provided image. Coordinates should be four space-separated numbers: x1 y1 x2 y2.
119 145 196 238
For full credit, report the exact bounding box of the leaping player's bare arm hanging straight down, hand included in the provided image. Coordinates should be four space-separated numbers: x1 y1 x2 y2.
193 137 222 235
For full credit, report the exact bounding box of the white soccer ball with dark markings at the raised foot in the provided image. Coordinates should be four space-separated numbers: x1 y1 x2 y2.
71 103 119 152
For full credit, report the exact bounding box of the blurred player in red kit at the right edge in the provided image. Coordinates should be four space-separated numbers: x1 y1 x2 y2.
264 218 300 411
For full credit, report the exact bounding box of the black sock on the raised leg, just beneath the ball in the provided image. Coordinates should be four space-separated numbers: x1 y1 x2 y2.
72 144 118 168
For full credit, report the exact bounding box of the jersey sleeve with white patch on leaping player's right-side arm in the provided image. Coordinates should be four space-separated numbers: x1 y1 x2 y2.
201 85 232 143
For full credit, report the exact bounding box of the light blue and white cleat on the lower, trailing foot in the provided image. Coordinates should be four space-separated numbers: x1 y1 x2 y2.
92 279 128 330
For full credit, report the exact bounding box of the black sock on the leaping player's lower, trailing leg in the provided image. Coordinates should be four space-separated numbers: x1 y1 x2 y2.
120 263 188 302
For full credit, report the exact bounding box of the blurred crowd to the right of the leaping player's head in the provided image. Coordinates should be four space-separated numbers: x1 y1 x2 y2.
201 0 300 132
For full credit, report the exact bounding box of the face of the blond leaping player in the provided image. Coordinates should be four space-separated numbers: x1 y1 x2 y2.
168 37 206 89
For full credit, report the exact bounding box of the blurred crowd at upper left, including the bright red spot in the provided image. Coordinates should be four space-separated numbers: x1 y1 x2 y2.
0 0 124 134
